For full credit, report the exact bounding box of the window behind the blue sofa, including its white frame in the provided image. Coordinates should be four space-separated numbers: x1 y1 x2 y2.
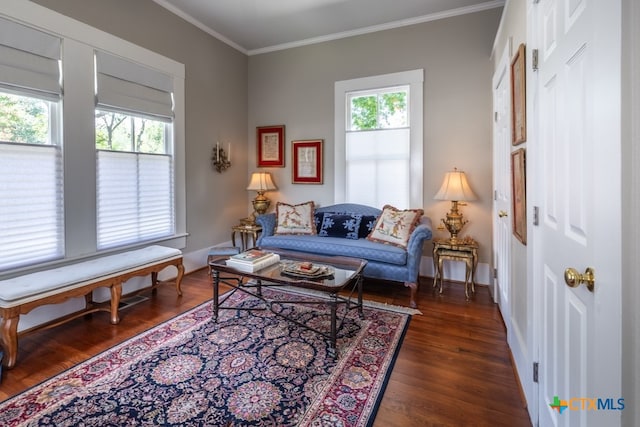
335 70 423 208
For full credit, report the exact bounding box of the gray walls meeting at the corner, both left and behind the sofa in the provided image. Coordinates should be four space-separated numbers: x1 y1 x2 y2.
36 0 501 270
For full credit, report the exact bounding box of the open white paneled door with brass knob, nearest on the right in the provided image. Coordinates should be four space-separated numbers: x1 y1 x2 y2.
527 0 630 426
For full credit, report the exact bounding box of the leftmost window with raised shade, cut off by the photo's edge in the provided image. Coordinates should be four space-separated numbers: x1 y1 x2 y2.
0 18 65 271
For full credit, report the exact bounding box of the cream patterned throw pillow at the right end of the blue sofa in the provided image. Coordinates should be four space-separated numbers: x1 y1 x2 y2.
367 205 424 248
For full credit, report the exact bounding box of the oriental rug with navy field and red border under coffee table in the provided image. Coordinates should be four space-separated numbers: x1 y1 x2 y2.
0 289 411 427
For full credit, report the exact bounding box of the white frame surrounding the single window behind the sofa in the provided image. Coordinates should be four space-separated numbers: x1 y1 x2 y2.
334 69 424 208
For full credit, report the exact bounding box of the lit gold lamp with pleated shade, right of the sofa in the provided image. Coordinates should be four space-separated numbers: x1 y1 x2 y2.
434 168 476 242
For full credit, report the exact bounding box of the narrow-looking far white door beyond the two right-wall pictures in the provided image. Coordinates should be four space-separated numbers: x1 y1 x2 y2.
493 46 511 326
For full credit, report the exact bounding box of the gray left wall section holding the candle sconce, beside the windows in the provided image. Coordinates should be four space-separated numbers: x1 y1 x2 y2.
34 0 248 265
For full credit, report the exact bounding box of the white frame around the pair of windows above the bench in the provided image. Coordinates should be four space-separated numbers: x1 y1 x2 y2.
0 2 187 274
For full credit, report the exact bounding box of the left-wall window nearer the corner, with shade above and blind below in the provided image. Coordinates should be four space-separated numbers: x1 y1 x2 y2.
95 52 175 249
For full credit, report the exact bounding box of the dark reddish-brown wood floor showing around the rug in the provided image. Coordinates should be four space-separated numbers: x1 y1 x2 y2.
0 269 531 427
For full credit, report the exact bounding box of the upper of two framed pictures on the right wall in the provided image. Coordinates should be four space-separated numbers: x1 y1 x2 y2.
511 44 527 145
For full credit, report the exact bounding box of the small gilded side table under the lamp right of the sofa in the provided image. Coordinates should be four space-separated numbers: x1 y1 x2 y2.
433 237 478 299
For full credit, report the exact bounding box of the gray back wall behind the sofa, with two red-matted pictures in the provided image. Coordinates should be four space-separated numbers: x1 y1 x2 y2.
248 9 501 263
